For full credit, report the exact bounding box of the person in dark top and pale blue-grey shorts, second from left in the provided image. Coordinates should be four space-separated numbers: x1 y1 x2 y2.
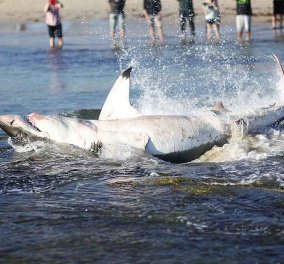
108 0 125 47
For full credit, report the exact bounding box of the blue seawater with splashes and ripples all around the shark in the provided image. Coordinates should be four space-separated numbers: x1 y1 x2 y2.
0 20 284 263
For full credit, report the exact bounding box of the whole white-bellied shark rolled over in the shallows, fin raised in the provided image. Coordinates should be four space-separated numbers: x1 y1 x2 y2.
0 55 284 162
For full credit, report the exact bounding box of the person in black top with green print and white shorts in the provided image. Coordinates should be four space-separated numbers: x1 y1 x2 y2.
236 0 252 41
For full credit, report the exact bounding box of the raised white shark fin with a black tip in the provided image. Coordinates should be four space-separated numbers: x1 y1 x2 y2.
99 67 141 120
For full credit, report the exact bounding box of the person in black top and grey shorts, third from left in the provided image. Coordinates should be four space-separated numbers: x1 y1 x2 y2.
143 0 164 46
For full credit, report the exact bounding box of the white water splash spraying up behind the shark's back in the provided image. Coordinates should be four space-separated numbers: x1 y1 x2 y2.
116 43 277 114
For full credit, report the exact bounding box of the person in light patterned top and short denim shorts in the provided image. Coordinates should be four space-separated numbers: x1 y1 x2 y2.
203 0 221 41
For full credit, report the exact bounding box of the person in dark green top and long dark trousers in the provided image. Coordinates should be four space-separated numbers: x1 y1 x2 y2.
177 0 195 43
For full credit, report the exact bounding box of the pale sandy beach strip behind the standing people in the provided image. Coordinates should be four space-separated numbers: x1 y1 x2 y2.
0 0 272 23
